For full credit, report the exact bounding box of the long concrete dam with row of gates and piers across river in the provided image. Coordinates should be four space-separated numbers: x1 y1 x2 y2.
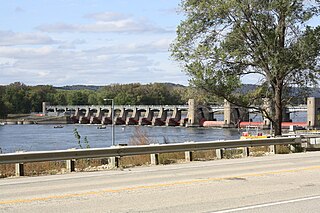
39 97 320 128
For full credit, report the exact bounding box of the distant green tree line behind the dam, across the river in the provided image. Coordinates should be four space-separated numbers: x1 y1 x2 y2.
0 82 213 118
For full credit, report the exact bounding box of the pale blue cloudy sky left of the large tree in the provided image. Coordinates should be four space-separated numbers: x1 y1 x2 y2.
0 0 188 86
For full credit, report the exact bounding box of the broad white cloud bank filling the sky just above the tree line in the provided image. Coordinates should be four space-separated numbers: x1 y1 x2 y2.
0 42 186 85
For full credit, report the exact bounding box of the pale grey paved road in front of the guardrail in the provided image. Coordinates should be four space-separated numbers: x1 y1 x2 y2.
0 152 320 213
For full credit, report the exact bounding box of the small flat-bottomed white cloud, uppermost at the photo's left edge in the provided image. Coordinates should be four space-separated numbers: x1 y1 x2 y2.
0 31 58 46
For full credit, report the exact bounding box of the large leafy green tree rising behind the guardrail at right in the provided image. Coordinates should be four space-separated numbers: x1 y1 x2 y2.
171 0 320 135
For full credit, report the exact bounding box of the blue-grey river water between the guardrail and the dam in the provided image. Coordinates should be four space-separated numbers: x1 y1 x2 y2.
0 112 306 153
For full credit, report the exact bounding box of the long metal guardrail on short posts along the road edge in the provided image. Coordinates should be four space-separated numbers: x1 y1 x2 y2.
0 137 303 176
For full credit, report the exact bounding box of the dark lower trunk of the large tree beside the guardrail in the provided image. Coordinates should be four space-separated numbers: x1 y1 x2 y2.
273 82 282 136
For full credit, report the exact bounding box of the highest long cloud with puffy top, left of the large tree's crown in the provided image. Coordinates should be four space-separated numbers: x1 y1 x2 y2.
36 12 171 33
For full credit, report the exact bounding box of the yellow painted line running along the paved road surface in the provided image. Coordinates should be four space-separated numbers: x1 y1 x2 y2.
0 166 320 205
